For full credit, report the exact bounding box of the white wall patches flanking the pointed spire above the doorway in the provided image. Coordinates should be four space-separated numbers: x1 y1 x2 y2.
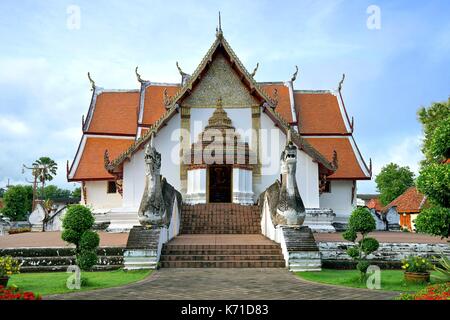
190 108 252 147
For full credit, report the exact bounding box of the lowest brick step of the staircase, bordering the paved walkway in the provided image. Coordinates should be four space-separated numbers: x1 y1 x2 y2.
161 260 285 268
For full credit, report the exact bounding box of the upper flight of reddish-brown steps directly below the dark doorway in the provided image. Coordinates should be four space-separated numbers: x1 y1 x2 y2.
181 203 261 234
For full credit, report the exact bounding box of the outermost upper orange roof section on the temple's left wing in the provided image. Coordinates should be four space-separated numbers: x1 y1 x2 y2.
87 91 139 134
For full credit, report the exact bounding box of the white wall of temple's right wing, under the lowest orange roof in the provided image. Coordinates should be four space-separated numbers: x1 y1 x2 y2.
320 180 356 223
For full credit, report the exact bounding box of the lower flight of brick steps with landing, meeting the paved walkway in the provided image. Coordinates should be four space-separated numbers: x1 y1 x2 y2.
160 234 285 268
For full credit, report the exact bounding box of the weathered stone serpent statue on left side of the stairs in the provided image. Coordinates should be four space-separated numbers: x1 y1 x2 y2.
138 137 167 226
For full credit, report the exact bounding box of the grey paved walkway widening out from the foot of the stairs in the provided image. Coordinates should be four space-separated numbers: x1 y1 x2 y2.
45 268 398 300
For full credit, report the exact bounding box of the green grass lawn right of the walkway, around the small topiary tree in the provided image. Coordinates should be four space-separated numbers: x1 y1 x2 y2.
296 269 442 292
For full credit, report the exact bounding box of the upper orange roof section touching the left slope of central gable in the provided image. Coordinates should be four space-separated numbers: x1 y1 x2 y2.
142 85 180 125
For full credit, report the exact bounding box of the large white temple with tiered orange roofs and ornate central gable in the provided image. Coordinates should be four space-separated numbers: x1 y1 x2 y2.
67 21 372 231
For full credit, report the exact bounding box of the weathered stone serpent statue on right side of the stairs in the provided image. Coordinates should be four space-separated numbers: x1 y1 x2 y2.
275 134 306 226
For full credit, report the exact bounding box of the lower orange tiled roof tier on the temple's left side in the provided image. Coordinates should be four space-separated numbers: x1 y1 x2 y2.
71 137 134 181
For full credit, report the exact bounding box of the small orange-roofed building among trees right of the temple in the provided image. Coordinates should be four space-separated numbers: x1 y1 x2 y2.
381 187 428 231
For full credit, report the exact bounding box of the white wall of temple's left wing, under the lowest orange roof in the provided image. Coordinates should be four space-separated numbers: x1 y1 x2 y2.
86 181 122 209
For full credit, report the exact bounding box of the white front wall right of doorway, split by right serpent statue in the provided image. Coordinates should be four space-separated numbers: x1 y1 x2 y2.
253 113 320 208
